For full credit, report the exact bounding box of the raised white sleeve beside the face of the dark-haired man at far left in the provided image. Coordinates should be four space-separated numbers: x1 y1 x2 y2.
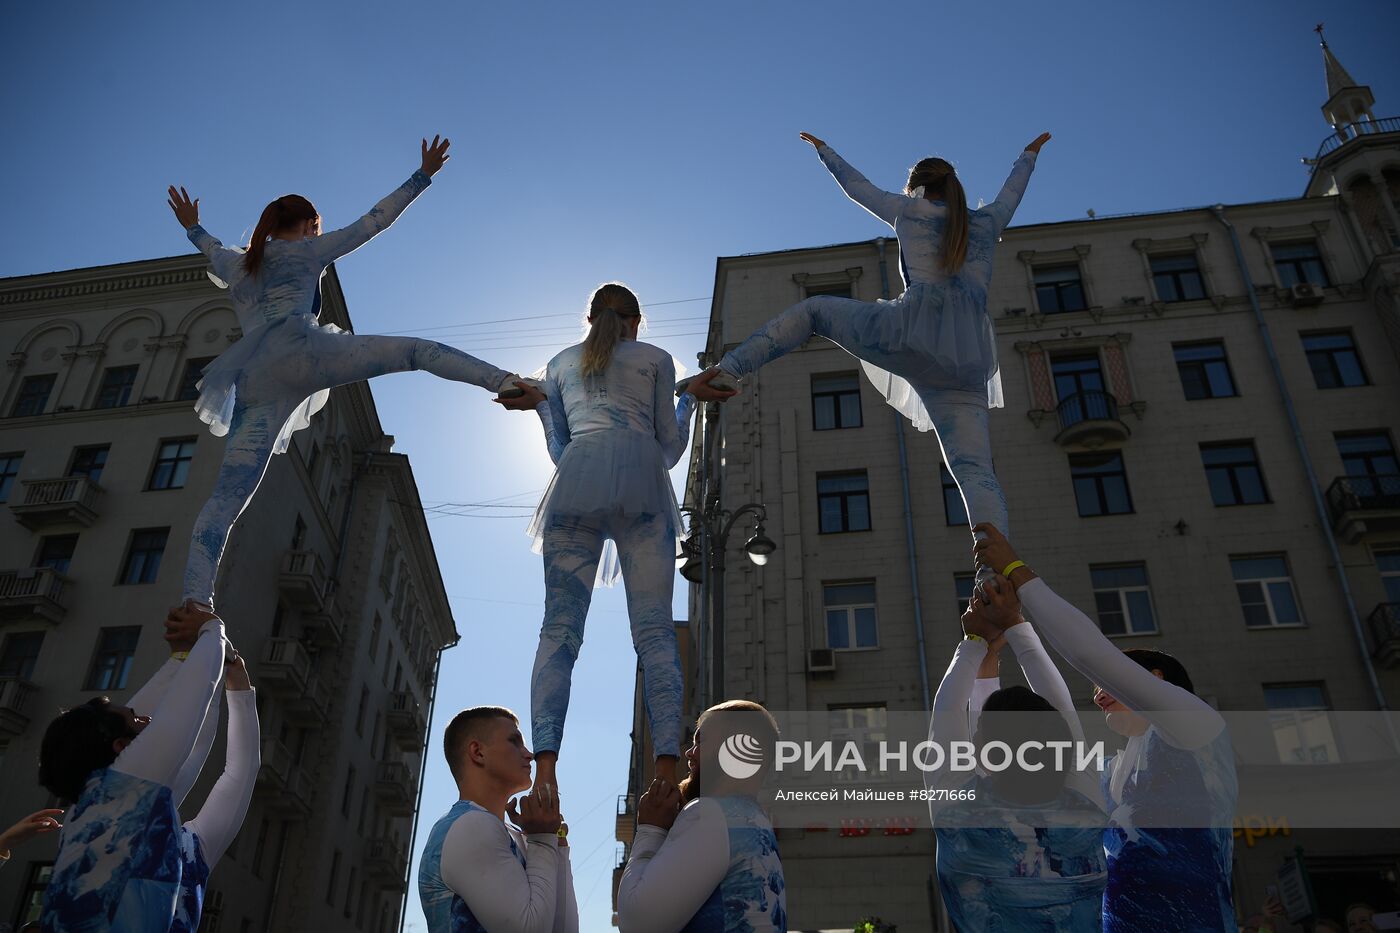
112 618 225 787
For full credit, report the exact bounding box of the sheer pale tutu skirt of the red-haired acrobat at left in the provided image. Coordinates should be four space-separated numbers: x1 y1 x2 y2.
195 314 346 454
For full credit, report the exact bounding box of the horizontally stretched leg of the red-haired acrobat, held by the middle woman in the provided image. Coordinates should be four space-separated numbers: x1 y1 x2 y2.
312 333 511 391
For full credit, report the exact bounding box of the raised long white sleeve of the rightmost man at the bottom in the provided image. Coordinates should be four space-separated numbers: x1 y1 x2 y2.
1018 577 1225 748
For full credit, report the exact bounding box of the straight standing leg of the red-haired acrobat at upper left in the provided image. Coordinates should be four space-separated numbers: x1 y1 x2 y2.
183 402 294 605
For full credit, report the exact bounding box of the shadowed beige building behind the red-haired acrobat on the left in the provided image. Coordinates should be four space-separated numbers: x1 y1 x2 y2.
0 256 458 933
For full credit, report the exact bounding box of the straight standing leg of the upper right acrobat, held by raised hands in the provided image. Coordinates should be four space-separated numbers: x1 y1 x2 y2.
918 388 1011 580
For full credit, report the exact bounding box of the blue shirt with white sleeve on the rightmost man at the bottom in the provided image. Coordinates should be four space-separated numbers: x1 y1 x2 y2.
1019 579 1239 933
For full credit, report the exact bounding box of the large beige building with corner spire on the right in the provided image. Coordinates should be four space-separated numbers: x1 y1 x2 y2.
618 39 1400 933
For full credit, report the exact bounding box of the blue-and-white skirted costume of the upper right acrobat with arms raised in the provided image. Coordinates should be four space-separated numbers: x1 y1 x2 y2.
720 146 1036 549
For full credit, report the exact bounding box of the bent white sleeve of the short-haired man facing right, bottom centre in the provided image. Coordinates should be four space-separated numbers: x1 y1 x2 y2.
441 810 562 933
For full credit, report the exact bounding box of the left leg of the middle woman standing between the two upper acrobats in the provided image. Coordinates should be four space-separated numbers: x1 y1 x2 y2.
529 516 603 786
